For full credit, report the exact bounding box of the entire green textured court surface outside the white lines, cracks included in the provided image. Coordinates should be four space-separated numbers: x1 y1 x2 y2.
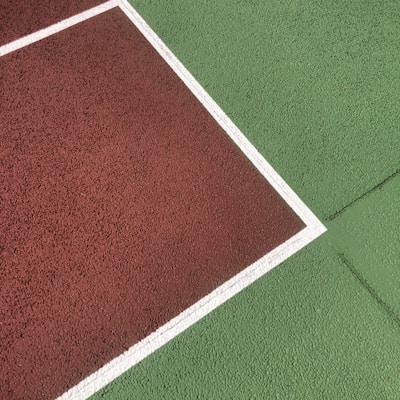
93 0 400 400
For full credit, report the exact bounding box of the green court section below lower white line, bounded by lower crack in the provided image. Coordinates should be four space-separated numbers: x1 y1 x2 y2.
93 237 400 400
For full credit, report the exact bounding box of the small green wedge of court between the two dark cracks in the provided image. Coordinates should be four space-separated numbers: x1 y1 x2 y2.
332 176 400 323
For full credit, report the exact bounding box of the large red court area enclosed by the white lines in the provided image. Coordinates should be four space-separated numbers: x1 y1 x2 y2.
0 9 304 399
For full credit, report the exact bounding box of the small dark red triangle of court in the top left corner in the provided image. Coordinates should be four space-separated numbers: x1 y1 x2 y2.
0 0 105 45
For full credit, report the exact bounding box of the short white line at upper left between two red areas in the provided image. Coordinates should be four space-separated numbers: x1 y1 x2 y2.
0 0 118 57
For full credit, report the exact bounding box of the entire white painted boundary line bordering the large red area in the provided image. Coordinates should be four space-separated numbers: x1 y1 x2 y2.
0 0 326 400
